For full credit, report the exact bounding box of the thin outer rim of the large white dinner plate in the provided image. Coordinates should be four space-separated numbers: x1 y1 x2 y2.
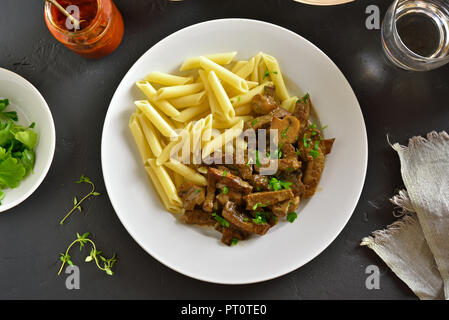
101 18 368 285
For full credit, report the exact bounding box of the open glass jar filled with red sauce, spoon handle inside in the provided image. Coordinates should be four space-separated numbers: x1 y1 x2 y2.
45 0 124 59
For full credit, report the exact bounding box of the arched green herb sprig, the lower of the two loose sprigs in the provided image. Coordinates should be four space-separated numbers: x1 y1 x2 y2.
58 232 117 276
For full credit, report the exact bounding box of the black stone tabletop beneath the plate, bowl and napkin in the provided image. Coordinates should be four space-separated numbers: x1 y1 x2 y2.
0 0 449 299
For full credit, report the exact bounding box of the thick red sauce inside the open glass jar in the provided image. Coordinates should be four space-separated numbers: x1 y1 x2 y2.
51 0 98 31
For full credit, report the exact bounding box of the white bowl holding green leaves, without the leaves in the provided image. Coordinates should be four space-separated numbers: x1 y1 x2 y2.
0 68 56 212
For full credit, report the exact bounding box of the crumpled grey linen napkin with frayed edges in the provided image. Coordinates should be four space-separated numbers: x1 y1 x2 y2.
361 132 449 299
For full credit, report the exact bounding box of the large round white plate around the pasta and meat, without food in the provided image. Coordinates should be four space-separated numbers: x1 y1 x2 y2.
101 19 367 284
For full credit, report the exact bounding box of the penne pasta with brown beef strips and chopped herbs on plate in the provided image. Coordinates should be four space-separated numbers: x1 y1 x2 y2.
129 52 334 245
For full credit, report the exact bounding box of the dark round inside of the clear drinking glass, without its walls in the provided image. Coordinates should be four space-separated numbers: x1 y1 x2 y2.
396 13 440 57
